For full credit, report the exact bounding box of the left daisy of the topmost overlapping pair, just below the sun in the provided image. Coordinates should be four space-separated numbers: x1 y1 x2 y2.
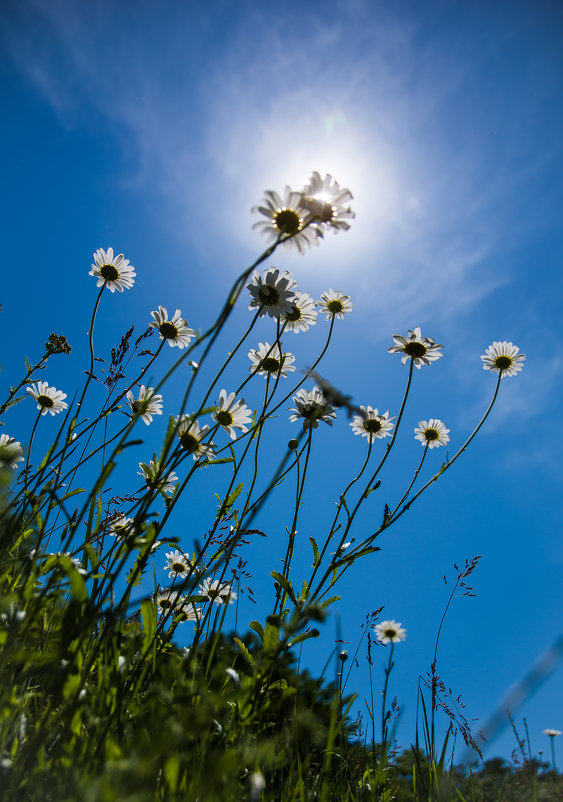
251 187 322 253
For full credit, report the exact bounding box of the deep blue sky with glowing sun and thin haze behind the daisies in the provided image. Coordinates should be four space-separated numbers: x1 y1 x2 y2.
0 0 563 756
